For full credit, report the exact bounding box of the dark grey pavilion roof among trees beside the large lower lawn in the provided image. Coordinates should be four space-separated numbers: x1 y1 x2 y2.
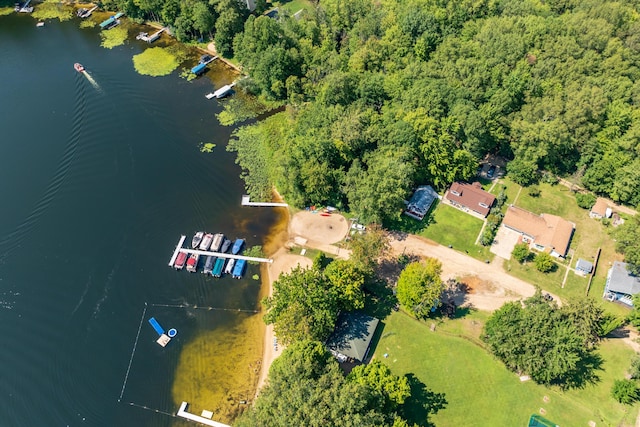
327 312 379 362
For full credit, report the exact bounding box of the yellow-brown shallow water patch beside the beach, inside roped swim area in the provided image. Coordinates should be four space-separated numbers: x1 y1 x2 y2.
172 313 265 424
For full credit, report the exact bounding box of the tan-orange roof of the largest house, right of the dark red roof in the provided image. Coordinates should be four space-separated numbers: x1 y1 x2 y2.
502 206 575 256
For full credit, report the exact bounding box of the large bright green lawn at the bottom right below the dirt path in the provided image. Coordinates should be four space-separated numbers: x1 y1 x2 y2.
374 312 639 427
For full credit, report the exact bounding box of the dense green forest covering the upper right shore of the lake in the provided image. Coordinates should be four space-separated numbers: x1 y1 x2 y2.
97 0 640 226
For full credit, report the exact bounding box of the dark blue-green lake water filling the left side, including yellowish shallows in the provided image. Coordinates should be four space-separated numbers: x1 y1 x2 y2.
0 14 278 426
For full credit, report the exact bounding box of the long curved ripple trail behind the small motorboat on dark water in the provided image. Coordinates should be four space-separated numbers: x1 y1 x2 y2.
0 80 85 263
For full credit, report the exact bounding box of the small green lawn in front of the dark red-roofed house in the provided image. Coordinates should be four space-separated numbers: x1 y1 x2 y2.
417 203 493 261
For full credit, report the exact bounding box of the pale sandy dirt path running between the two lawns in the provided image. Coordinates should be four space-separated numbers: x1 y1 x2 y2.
390 233 559 311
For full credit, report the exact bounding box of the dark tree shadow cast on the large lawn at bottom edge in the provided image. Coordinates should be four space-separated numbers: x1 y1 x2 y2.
402 374 449 427
